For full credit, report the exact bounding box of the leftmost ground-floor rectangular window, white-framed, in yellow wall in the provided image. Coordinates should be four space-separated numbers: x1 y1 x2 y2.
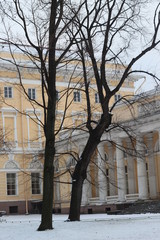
7 173 17 195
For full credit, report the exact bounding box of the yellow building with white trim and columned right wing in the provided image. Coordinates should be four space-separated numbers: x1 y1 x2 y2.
0 49 160 214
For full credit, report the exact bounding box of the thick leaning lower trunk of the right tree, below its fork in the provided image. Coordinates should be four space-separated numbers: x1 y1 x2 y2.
68 113 112 221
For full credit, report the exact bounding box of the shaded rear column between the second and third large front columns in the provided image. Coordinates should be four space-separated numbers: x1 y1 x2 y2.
127 143 136 194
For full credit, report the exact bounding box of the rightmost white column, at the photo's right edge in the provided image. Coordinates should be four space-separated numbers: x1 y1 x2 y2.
148 134 157 198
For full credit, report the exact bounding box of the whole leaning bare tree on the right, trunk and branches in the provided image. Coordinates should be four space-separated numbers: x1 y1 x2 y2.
69 0 160 221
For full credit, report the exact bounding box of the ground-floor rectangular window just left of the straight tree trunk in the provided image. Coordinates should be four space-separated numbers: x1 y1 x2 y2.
31 173 41 194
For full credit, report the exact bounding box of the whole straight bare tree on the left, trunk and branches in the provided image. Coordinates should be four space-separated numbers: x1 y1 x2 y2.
0 0 83 231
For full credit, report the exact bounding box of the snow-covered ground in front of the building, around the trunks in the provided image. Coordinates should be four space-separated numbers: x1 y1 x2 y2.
0 214 160 240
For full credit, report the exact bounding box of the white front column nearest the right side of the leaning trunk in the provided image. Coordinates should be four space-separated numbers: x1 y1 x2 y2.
98 143 107 202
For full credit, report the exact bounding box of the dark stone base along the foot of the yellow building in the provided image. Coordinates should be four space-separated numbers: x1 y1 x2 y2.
0 200 160 215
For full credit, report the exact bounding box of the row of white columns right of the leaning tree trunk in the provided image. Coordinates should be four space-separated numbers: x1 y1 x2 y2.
82 133 158 204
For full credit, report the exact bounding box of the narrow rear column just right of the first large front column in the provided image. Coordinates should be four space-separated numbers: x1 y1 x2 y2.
108 145 116 196
